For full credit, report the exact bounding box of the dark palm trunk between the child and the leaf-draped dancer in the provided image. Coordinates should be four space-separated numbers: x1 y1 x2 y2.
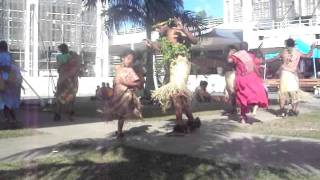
145 26 155 98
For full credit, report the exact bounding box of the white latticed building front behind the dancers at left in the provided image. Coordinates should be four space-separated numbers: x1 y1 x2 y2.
0 0 108 77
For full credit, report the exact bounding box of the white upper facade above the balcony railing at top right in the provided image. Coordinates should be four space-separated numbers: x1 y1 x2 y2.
224 0 320 23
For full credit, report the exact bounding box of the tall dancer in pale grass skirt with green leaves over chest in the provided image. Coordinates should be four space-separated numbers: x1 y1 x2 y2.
146 18 201 133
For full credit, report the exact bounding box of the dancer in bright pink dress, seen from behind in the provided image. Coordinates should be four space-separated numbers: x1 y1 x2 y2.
228 42 268 123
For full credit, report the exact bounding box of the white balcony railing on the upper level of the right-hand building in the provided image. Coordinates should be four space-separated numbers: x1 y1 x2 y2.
255 16 320 30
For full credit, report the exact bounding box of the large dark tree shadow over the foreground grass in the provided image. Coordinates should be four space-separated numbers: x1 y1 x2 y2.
0 133 319 180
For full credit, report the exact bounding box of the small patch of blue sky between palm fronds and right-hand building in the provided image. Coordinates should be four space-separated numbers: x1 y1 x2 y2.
184 0 223 17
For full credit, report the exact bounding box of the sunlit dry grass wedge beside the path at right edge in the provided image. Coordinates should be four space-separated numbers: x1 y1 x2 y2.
237 112 320 139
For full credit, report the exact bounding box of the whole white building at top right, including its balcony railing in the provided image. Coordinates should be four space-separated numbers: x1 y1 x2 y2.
224 0 320 48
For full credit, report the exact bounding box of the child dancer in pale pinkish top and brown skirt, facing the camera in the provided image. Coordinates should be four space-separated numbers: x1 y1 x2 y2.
106 50 142 138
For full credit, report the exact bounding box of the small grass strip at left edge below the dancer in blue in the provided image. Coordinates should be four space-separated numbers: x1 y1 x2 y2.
0 129 42 139
